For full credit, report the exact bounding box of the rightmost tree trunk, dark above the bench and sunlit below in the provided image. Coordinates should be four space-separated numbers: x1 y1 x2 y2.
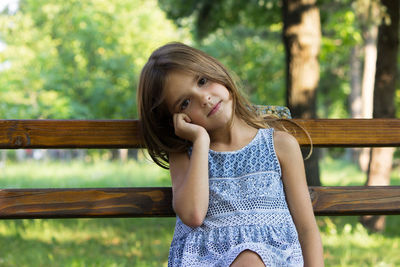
361 0 400 231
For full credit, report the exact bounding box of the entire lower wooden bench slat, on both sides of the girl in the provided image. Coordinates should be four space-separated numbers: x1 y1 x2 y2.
0 186 400 219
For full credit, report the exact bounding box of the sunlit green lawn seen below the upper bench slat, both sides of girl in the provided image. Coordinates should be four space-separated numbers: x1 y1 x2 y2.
0 155 400 266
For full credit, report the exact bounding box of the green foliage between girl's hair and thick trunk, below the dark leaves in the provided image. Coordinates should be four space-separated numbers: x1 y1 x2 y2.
200 23 285 105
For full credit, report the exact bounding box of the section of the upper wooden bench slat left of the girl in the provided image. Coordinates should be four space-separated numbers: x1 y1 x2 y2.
0 120 141 149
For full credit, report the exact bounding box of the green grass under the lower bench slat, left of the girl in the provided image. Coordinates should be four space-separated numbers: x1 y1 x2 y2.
0 218 174 267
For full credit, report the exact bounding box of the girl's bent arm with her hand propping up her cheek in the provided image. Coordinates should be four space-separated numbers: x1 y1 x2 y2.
169 114 210 227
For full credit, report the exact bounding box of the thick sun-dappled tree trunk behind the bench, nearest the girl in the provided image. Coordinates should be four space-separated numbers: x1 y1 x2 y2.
282 0 321 185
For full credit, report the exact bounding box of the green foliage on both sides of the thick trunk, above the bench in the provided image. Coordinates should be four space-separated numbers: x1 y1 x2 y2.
159 0 362 117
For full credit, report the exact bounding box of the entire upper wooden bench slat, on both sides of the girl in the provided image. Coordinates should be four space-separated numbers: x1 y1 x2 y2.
0 119 400 149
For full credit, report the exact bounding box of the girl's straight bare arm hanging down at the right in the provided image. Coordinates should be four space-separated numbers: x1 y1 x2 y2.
274 131 324 266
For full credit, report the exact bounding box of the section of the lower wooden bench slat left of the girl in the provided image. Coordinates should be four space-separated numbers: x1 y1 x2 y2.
0 187 174 219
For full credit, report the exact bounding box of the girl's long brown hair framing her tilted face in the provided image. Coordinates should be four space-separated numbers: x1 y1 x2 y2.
137 42 268 168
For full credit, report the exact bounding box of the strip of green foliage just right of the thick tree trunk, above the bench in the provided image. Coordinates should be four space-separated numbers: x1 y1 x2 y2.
317 0 363 119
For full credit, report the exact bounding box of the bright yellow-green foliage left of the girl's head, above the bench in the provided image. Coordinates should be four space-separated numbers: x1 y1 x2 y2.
0 0 184 119
